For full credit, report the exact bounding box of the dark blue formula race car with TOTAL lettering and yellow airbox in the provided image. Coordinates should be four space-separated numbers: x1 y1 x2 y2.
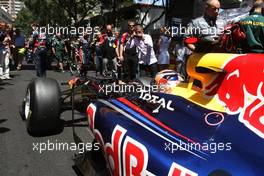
20 53 264 176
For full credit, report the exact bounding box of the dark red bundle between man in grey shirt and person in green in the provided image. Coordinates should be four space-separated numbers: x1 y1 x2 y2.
220 22 246 53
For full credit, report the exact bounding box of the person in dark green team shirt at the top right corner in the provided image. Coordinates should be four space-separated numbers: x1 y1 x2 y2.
241 0 264 53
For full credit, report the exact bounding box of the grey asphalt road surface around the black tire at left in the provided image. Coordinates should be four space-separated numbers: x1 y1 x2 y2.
0 66 93 176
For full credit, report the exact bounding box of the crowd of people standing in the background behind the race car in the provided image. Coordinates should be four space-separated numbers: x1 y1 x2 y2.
0 0 264 82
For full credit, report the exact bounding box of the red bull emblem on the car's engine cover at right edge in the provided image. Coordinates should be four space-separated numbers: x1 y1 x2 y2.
205 54 264 138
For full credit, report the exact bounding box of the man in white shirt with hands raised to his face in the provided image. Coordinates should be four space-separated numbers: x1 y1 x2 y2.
130 25 158 77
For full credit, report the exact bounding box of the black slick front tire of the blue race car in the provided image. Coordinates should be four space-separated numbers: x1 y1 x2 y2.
23 78 62 136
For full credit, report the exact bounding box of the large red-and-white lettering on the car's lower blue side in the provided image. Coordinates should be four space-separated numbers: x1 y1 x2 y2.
92 125 197 176
